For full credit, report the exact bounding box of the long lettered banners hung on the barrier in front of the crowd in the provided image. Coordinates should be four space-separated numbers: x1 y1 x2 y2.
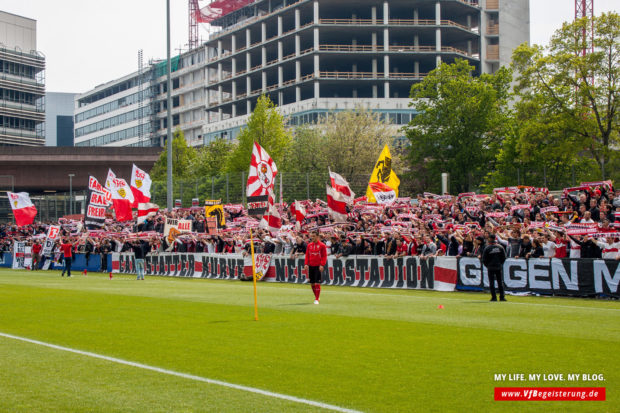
109 253 620 298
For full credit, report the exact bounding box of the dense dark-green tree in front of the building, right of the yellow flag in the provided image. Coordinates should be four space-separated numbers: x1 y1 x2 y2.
406 59 512 192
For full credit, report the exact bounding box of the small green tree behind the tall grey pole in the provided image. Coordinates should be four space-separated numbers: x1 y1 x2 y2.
151 129 196 181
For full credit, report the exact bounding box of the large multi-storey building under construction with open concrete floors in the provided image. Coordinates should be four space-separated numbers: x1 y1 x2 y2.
76 0 530 146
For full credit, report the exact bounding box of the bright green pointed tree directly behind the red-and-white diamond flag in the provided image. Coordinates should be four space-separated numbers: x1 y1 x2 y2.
227 95 291 172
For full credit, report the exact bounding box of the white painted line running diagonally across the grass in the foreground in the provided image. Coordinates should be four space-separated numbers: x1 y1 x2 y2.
0 332 361 413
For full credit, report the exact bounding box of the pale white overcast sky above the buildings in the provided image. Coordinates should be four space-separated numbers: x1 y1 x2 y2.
0 0 618 93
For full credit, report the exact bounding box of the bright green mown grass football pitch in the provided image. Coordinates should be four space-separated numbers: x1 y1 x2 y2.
0 269 620 412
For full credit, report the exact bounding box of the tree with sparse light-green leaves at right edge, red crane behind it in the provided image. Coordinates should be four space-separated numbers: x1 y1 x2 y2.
513 12 620 179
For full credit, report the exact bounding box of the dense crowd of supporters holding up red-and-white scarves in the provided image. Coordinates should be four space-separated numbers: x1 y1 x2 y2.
0 182 620 259
